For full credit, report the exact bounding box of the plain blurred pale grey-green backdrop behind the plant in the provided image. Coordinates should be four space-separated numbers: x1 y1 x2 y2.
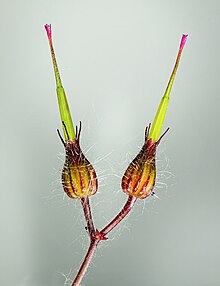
0 0 220 286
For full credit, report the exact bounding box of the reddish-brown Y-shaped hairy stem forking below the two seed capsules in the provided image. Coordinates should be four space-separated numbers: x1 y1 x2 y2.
72 196 137 286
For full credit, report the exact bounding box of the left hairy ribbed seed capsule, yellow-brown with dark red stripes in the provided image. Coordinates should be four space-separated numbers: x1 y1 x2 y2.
61 122 98 199
